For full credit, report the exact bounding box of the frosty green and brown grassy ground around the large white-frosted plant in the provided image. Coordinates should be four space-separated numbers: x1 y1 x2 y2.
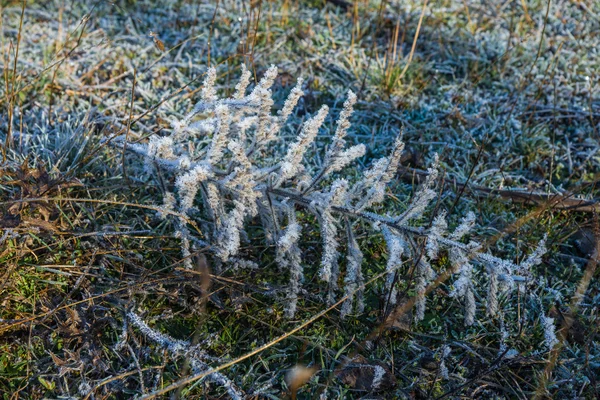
0 0 600 399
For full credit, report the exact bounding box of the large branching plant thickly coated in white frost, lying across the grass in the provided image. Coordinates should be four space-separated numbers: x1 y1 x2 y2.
113 66 545 325
